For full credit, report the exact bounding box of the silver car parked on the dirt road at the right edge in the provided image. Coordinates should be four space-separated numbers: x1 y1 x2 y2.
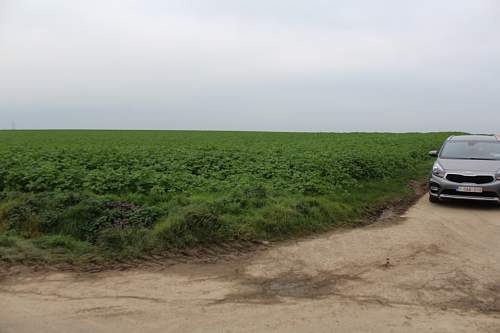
429 135 500 203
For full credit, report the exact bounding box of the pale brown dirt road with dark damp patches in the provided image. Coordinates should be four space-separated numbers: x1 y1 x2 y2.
0 197 500 333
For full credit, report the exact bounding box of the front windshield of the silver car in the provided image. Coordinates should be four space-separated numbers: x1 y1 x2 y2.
440 141 500 160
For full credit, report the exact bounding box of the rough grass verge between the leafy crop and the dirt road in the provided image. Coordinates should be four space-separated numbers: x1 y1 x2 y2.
0 162 430 265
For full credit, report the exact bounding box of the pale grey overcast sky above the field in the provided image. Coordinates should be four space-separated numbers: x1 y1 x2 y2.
0 0 500 133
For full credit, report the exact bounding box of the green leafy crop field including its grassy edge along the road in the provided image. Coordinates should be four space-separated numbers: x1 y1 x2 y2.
0 131 449 262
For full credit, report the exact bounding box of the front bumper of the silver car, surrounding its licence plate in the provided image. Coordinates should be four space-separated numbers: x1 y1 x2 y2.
429 175 500 203
